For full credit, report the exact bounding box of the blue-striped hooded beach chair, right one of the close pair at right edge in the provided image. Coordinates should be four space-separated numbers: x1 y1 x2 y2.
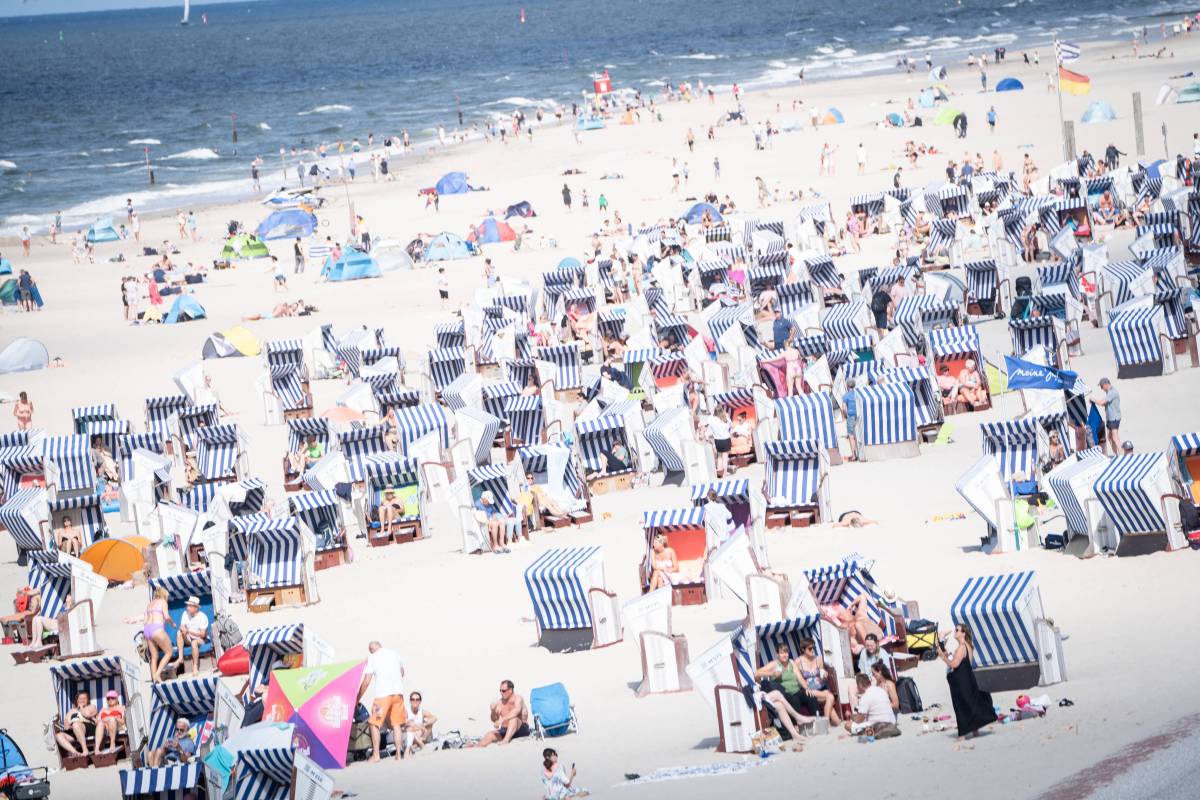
1092 452 1187 555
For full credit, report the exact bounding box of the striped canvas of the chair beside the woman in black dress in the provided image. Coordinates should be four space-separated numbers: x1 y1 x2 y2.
950 571 1042 667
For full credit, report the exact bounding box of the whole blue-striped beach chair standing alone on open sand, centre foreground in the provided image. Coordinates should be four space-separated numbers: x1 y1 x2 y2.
524 546 611 652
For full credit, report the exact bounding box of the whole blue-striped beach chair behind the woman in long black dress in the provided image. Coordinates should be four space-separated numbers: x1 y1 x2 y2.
950 571 1067 692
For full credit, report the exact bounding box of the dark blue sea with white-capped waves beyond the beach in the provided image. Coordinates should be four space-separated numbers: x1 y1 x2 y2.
0 0 1195 236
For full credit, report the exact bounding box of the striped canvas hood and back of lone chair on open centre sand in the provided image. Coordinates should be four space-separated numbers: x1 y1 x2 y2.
524 547 604 631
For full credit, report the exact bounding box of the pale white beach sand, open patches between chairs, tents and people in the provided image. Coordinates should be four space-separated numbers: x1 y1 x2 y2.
0 38 1200 798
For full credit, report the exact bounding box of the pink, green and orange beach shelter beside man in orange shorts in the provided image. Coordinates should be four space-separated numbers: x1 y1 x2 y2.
263 661 367 769
